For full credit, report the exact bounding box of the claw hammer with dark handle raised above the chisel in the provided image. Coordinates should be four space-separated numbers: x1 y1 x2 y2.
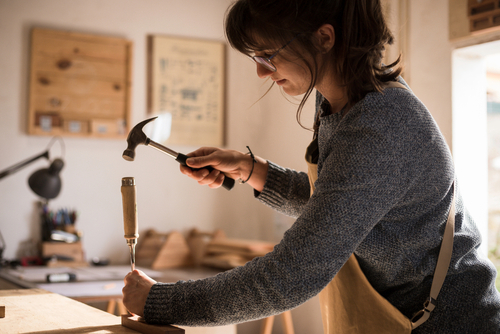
122 117 234 190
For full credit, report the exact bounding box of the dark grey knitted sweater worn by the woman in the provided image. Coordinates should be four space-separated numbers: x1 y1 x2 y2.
144 82 500 333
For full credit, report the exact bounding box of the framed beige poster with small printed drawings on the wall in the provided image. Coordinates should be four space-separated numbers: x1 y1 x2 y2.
148 35 225 146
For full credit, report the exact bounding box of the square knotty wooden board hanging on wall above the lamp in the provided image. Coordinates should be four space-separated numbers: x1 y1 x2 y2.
28 28 132 138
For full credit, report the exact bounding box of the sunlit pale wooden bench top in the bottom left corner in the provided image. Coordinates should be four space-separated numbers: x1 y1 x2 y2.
0 289 137 334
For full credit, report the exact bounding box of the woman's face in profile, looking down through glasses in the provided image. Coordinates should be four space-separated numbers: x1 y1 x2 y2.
255 49 311 96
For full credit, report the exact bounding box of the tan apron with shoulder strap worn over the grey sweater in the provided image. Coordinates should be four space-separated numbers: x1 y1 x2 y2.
306 83 455 334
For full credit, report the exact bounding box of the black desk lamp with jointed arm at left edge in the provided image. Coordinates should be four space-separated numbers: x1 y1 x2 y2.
0 137 64 200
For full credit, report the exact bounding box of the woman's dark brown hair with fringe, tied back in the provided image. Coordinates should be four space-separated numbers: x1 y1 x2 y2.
225 0 402 123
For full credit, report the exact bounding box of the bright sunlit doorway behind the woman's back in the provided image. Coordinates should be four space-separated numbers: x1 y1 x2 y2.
452 41 500 267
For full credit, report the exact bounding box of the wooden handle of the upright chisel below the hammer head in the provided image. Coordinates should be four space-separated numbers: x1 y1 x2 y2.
121 177 139 241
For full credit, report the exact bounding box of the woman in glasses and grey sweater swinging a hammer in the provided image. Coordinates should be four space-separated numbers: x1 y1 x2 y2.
123 0 500 333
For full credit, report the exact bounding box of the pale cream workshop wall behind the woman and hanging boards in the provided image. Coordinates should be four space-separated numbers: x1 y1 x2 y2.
0 0 500 333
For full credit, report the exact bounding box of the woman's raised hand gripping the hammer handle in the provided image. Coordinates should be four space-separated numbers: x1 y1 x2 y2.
180 147 267 191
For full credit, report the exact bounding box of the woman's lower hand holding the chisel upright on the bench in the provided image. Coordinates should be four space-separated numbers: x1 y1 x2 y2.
122 270 156 317
